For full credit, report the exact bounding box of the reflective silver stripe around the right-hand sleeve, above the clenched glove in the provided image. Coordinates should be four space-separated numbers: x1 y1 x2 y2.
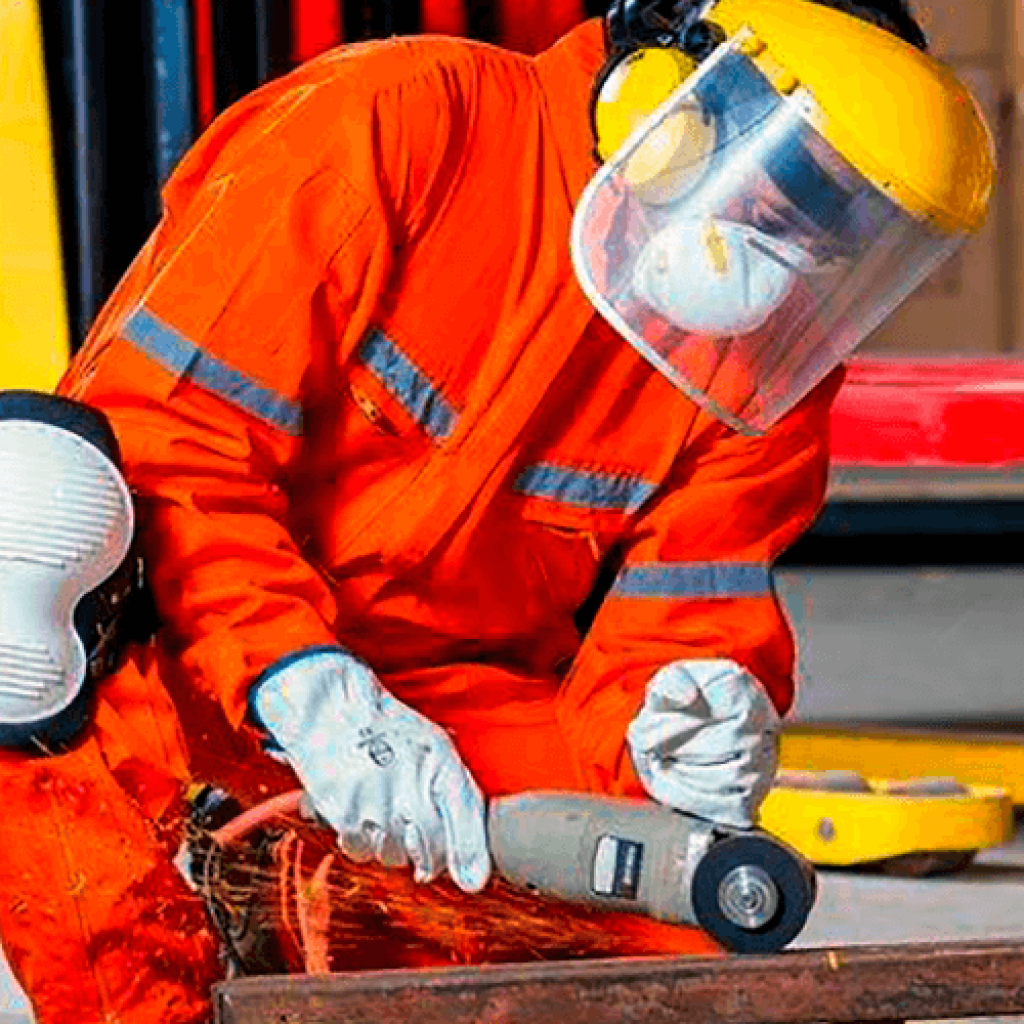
609 562 773 600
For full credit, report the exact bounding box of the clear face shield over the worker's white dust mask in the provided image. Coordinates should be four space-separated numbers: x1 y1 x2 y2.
572 36 963 434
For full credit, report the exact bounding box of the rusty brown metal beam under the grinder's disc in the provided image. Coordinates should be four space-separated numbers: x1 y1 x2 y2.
215 941 1024 1024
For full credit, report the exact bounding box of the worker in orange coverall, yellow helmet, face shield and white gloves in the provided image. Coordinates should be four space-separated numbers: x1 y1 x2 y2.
0 0 992 1024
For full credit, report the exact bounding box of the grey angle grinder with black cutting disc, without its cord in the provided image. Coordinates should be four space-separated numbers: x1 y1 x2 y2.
487 792 817 952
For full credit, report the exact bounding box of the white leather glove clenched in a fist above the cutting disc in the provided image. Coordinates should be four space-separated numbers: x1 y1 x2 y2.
626 659 779 828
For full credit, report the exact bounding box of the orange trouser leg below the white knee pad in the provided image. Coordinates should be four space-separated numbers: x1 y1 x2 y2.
0 647 221 1024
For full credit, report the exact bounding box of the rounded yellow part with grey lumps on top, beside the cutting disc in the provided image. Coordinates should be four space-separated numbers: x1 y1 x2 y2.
761 779 1014 867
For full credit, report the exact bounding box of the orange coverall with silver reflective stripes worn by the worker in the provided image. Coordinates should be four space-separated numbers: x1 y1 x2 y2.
0 20 838 1024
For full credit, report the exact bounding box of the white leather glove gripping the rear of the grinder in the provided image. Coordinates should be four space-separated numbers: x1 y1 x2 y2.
253 651 490 892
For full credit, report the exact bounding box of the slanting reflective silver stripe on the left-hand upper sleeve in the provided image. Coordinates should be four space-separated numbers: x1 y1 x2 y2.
121 308 302 437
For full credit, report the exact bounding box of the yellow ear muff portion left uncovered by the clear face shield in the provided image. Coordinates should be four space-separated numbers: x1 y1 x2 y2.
594 46 696 160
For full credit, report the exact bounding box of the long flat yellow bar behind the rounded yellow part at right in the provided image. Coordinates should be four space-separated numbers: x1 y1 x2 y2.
779 725 1024 805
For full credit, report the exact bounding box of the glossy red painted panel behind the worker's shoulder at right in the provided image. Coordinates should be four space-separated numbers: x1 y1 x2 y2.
833 358 1024 468
